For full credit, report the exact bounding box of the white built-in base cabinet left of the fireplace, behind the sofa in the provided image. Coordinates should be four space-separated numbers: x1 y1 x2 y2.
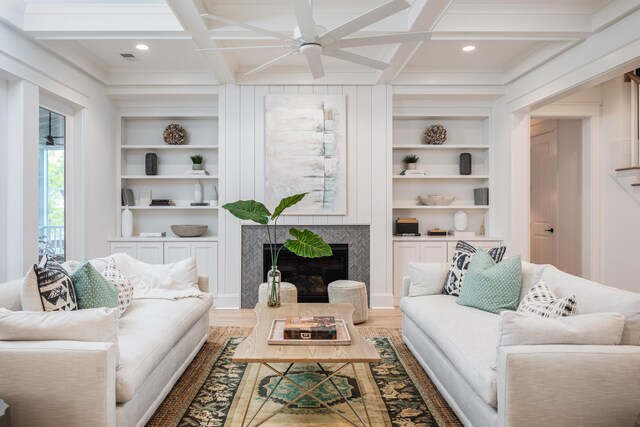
109 238 218 289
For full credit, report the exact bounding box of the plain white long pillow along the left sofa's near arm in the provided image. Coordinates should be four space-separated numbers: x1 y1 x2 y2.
0 307 120 365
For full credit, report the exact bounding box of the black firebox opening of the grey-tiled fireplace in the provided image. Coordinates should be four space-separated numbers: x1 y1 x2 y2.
262 244 349 302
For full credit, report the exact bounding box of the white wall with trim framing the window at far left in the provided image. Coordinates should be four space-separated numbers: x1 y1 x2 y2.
0 23 117 279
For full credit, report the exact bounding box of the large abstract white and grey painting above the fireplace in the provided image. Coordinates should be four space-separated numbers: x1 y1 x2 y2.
265 95 347 215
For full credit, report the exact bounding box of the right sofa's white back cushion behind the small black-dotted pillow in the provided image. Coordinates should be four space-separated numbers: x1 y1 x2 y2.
540 266 640 345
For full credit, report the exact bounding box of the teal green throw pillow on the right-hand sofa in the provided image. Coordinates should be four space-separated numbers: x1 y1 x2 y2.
457 249 522 314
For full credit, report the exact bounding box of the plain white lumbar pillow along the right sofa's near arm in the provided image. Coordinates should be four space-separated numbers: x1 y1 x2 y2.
498 311 624 346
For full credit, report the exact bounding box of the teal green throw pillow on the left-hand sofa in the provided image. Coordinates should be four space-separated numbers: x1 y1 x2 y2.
70 261 118 310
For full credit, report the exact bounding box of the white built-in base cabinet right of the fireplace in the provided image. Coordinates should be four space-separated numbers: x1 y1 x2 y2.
393 237 502 305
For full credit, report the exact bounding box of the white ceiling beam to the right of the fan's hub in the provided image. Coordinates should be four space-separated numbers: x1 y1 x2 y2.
376 0 453 84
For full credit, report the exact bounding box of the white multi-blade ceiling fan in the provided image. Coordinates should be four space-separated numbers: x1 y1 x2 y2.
198 0 431 79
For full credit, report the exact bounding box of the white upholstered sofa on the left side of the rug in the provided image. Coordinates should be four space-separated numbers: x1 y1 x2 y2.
0 266 212 427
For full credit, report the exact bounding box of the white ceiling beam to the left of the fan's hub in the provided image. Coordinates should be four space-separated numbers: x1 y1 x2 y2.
166 0 235 84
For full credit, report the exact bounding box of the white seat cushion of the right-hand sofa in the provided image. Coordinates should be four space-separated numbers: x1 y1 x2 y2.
400 295 500 407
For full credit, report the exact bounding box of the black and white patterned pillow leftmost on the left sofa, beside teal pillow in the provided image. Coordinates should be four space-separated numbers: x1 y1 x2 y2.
22 257 78 311
